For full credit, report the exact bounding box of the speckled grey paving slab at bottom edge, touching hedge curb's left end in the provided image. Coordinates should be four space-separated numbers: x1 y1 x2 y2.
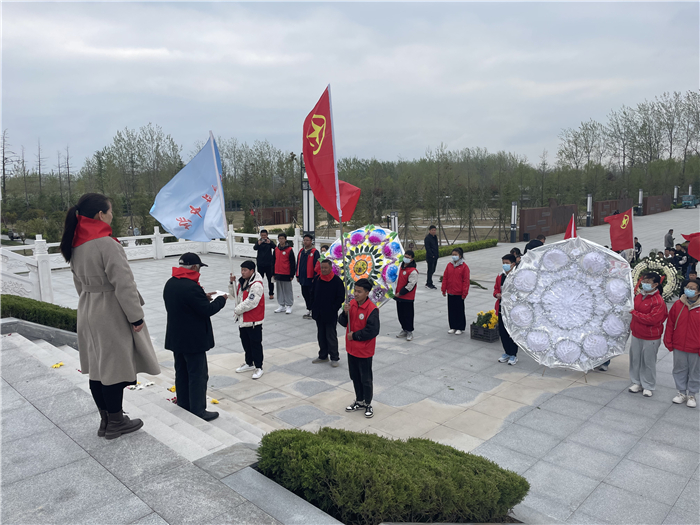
132 463 245 525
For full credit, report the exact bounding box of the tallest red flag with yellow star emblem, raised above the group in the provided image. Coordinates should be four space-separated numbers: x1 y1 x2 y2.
303 84 360 222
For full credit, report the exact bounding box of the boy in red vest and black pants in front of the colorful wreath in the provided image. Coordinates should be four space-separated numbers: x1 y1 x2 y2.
338 279 379 418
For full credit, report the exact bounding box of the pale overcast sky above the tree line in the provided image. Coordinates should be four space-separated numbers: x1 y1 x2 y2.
2 2 700 170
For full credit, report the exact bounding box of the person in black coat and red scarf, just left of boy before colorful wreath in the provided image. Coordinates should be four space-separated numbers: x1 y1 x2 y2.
311 259 345 367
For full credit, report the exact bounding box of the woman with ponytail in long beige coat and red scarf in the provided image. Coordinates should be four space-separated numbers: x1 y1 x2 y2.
61 193 160 439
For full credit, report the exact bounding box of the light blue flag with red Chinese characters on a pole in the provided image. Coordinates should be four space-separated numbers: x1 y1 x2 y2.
150 132 227 242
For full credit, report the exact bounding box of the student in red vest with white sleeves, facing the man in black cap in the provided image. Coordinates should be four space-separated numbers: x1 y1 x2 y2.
229 261 265 379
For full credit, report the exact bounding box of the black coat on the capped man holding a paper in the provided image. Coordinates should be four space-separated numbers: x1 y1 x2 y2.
163 277 226 354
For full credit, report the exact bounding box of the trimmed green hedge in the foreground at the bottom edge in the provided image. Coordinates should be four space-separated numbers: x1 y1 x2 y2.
258 428 530 525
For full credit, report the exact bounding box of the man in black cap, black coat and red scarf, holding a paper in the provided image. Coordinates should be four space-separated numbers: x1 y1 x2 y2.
163 253 228 421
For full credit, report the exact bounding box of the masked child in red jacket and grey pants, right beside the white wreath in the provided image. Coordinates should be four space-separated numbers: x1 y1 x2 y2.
629 272 668 397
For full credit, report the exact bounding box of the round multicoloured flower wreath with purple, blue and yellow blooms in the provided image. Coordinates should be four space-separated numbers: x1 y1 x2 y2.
321 224 403 306
